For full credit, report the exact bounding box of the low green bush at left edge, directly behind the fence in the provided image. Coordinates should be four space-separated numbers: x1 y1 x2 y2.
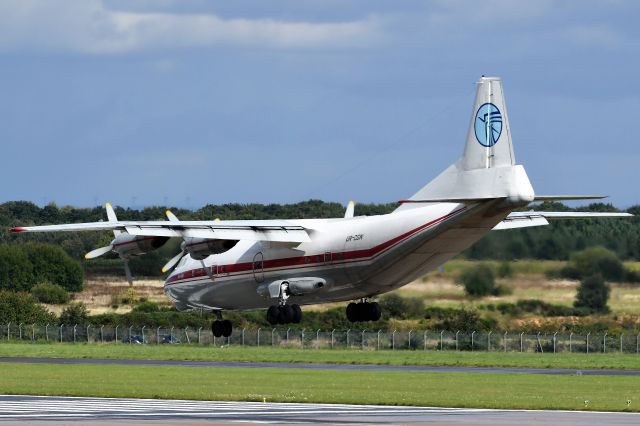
0 290 56 324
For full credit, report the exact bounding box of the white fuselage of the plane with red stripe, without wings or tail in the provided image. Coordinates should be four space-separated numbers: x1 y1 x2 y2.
165 203 514 310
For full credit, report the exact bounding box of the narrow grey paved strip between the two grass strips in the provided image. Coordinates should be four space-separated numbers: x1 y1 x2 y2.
0 357 640 376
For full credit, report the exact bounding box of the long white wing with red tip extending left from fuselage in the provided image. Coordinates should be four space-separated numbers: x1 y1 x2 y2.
9 220 311 243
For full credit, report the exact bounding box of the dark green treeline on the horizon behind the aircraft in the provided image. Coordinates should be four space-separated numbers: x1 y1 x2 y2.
0 200 640 276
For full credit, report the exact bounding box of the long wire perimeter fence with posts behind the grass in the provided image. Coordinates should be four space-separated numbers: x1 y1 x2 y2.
0 324 640 354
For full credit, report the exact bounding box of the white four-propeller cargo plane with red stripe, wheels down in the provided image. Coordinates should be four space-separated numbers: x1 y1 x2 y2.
11 76 631 337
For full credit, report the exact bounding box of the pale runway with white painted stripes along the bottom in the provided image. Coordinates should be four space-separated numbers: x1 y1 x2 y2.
0 395 640 426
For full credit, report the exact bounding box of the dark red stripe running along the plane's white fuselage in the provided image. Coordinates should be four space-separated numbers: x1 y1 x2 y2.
166 207 466 284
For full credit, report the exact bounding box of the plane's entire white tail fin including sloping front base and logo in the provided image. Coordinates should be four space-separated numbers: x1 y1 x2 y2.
398 76 534 210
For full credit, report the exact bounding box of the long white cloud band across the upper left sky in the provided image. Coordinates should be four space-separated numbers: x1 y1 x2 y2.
0 0 380 54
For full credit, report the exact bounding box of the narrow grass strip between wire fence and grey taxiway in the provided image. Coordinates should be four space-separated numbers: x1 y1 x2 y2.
0 343 640 369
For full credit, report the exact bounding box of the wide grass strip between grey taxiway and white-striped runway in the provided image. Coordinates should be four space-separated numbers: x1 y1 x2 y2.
0 364 640 411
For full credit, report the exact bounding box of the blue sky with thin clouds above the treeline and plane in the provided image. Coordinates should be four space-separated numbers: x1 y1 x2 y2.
0 0 640 207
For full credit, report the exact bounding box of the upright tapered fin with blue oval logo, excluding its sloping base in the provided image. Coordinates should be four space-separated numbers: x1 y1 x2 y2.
458 76 516 170
